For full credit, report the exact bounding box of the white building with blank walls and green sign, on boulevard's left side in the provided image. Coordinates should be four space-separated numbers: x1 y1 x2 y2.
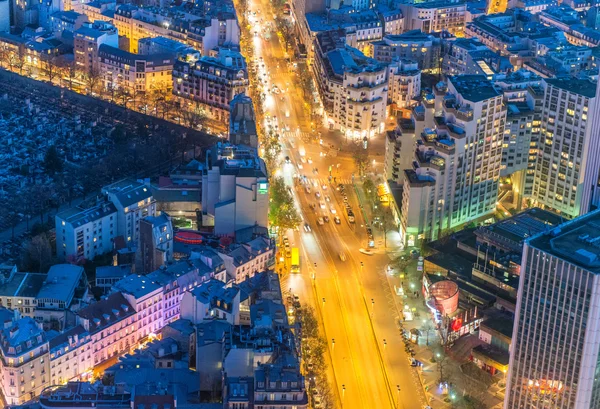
202 143 269 236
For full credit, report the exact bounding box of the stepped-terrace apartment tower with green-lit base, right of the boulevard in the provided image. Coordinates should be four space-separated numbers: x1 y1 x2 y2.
401 75 506 246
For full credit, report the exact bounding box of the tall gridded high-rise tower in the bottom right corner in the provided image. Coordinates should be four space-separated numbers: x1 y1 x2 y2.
504 211 600 409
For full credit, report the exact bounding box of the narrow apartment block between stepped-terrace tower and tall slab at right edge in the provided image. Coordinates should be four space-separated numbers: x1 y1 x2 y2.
495 70 544 209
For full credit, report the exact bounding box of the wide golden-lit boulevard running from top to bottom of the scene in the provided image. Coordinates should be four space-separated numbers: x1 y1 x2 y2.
243 0 434 409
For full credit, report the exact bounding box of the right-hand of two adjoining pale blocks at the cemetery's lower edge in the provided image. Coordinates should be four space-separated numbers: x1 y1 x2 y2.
102 180 156 244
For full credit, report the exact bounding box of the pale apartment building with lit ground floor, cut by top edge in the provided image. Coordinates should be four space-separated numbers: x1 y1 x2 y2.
399 0 467 36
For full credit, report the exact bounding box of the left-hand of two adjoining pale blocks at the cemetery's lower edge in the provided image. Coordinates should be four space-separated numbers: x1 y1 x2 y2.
55 202 119 260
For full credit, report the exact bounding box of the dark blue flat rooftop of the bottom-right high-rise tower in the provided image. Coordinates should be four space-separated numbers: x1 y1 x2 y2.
528 210 600 274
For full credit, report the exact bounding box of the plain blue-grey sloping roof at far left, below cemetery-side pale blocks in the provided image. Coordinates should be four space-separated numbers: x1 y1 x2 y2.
37 264 85 307
